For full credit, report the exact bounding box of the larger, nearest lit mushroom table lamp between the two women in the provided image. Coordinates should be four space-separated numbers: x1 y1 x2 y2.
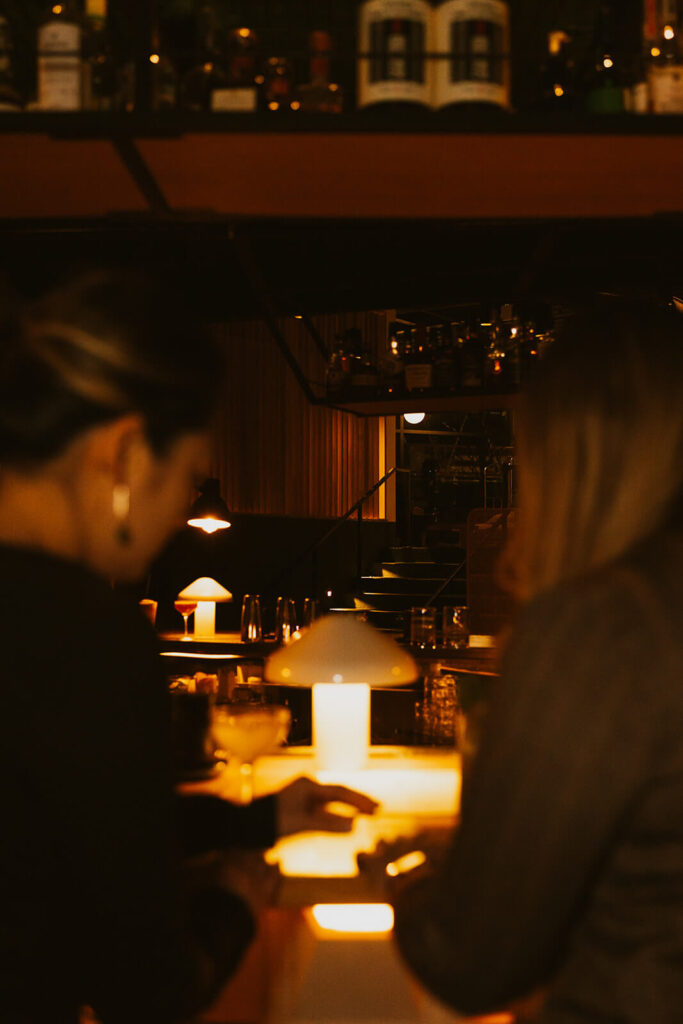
265 614 418 771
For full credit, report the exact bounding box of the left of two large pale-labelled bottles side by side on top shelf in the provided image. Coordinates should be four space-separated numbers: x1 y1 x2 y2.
357 0 431 108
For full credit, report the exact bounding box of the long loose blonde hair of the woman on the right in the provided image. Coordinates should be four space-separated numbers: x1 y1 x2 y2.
501 299 683 600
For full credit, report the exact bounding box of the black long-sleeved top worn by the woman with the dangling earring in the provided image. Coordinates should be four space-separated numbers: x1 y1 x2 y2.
0 546 274 1024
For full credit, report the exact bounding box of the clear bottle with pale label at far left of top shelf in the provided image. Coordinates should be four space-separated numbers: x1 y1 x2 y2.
37 0 83 111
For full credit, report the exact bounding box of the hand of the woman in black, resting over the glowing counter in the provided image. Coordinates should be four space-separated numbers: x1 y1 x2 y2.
276 777 379 836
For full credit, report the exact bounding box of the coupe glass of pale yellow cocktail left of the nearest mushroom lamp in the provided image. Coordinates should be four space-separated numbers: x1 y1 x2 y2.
212 703 292 804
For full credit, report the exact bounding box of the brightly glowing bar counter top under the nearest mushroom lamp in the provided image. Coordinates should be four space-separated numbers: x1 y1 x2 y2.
203 746 461 904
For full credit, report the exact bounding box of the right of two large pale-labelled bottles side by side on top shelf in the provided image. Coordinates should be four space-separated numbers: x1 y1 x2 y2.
433 0 510 110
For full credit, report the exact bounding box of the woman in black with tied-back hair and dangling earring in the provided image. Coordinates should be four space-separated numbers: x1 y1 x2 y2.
0 274 374 1024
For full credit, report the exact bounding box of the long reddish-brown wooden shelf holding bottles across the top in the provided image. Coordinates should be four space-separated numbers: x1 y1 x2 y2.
0 112 683 221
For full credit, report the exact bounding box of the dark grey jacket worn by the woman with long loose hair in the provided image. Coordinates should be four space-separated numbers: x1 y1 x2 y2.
396 538 683 1024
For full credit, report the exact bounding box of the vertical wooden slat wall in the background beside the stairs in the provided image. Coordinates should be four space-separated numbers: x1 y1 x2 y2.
208 312 389 519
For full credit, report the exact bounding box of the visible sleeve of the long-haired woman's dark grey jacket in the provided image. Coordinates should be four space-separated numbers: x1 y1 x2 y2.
396 585 657 1014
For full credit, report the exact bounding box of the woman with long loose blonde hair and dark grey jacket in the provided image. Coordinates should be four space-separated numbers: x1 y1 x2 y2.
396 299 683 1024
